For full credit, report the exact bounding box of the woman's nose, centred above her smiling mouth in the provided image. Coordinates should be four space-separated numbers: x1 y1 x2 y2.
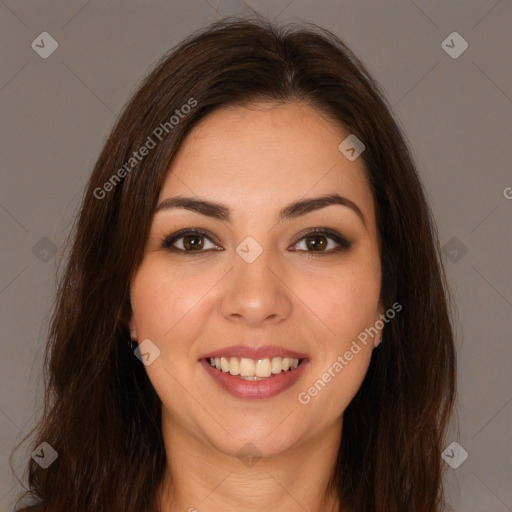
221 250 293 327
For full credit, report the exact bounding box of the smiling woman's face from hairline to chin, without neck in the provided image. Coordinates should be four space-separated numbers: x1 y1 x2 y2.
130 103 383 456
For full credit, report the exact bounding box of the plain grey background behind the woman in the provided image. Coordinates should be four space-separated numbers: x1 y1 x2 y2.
0 0 512 512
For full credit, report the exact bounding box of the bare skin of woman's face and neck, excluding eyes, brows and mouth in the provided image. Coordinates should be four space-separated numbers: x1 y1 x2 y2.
130 102 384 512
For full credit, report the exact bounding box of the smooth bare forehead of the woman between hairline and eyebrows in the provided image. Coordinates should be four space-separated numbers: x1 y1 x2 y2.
160 103 373 226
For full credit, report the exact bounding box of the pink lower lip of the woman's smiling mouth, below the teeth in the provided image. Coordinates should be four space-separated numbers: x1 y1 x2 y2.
199 359 308 399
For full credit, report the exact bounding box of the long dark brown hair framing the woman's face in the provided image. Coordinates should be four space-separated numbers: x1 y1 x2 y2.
15 18 456 512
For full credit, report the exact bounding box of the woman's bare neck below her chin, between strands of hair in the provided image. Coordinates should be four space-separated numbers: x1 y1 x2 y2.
158 419 342 512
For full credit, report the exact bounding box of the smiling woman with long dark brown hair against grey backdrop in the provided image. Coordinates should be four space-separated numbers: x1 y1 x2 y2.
10 14 456 512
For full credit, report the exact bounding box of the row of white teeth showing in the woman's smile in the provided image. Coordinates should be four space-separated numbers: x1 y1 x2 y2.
210 357 299 380
